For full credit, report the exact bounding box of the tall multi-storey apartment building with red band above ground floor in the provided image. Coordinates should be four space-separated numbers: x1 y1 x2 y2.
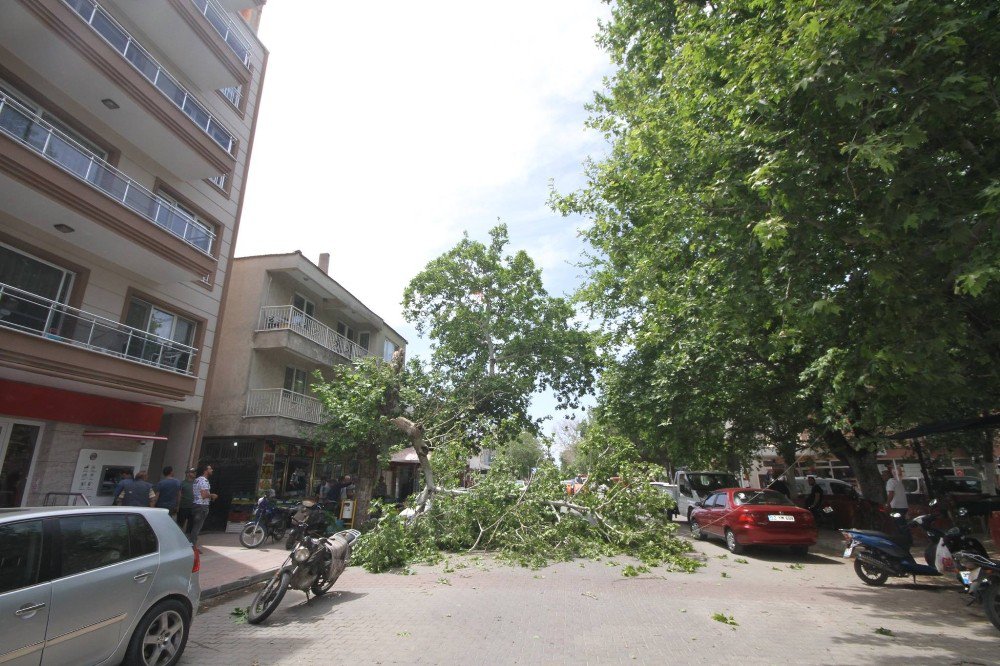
0 0 267 507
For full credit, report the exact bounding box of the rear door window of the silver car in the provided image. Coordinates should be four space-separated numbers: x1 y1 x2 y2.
59 513 131 576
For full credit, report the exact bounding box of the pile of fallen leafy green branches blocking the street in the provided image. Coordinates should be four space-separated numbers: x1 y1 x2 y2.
351 437 701 572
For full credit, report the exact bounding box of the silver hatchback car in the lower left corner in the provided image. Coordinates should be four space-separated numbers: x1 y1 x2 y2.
0 506 201 666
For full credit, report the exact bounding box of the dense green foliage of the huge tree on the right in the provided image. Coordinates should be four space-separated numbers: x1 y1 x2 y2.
556 0 1000 499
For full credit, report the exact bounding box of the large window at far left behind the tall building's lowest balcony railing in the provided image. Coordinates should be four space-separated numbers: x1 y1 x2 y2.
0 243 76 332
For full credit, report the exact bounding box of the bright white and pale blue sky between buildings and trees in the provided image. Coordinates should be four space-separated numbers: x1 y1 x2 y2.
236 0 611 430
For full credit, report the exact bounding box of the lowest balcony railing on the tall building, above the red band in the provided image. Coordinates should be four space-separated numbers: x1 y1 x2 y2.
0 282 198 375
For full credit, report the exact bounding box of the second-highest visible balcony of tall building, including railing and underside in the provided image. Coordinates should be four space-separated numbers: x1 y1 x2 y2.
0 0 232 181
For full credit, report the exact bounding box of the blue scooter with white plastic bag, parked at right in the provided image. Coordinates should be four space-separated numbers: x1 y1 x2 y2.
840 500 986 586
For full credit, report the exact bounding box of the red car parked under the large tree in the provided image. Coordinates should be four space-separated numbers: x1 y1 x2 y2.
691 488 817 556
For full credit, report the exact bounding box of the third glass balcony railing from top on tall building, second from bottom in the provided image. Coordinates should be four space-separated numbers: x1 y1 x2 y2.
0 92 215 257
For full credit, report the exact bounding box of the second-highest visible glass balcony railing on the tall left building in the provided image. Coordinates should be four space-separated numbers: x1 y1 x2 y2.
63 0 236 155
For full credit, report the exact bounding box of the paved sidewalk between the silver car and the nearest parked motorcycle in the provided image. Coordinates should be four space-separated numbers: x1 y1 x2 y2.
198 532 288 601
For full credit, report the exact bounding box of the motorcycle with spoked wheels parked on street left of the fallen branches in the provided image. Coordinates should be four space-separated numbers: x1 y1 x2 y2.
247 530 361 624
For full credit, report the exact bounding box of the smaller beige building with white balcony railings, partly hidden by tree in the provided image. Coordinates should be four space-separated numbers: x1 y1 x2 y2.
200 252 406 526
